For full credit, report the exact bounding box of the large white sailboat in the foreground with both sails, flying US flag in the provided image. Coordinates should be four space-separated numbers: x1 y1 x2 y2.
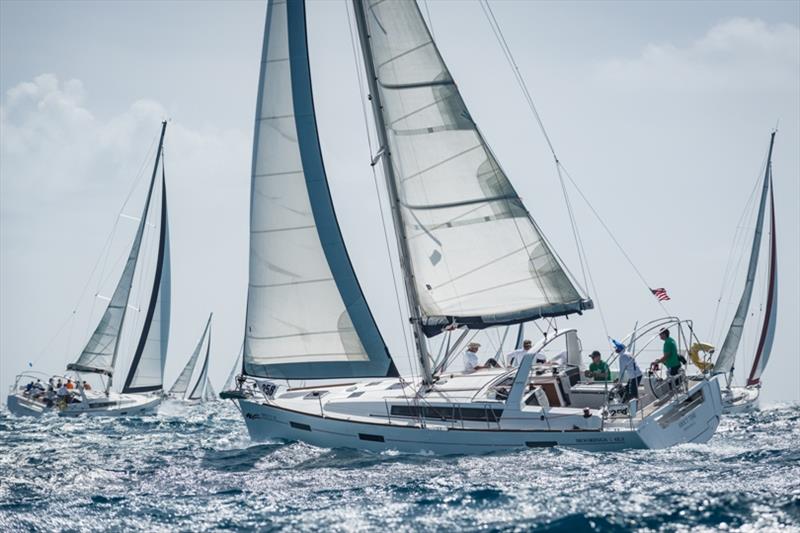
222 0 721 454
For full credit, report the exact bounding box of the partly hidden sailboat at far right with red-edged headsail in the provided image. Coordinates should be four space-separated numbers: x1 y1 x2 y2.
712 131 778 414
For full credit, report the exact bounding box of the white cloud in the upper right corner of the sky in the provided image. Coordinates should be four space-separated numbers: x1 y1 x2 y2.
596 18 800 92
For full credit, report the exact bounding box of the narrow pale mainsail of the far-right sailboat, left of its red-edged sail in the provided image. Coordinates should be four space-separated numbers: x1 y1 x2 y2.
714 132 775 376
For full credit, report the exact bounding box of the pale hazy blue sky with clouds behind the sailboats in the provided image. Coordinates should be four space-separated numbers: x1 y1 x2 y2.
0 0 800 405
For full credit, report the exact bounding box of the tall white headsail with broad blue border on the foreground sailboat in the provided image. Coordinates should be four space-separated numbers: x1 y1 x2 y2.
244 0 397 379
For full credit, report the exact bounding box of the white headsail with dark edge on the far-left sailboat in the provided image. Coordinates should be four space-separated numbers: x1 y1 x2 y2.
122 177 171 393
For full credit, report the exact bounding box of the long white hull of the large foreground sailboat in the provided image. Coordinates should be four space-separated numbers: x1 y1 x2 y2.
237 374 721 455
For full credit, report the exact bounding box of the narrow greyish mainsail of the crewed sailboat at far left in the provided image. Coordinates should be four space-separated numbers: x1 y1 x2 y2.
67 122 167 378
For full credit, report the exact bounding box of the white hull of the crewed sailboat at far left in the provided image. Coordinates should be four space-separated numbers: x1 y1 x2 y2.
7 392 161 417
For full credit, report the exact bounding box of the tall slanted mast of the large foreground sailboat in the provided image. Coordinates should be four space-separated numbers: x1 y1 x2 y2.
353 0 433 385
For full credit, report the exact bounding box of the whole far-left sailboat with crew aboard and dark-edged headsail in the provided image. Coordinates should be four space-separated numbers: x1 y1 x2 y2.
7 122 170 416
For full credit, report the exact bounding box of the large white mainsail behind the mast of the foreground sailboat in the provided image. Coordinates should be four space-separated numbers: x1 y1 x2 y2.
356 0 592 335
